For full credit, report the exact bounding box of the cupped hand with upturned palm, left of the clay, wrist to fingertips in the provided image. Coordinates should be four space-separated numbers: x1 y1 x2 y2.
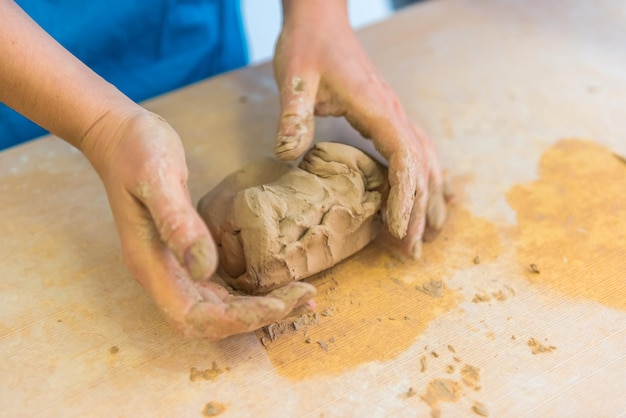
80 107 315 340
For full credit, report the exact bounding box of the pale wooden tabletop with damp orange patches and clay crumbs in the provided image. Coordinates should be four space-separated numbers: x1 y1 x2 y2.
0 0 626 417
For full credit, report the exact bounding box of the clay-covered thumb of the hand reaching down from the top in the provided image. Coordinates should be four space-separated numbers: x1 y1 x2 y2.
274 75 319 160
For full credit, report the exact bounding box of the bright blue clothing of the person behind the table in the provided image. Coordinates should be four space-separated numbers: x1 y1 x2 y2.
0 0 247 149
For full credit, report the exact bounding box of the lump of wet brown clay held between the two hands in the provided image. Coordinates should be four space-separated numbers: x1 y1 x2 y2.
198 142 387 294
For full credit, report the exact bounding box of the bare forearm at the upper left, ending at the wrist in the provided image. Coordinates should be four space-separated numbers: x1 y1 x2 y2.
0 0 137 149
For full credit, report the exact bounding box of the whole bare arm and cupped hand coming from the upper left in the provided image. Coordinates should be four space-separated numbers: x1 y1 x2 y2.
0 1 315 340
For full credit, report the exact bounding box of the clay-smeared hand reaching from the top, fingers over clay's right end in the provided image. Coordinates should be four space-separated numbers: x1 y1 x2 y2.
274 0 445 258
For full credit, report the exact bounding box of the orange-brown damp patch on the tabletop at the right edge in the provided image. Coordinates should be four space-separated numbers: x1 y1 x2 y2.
507 140 626 310
